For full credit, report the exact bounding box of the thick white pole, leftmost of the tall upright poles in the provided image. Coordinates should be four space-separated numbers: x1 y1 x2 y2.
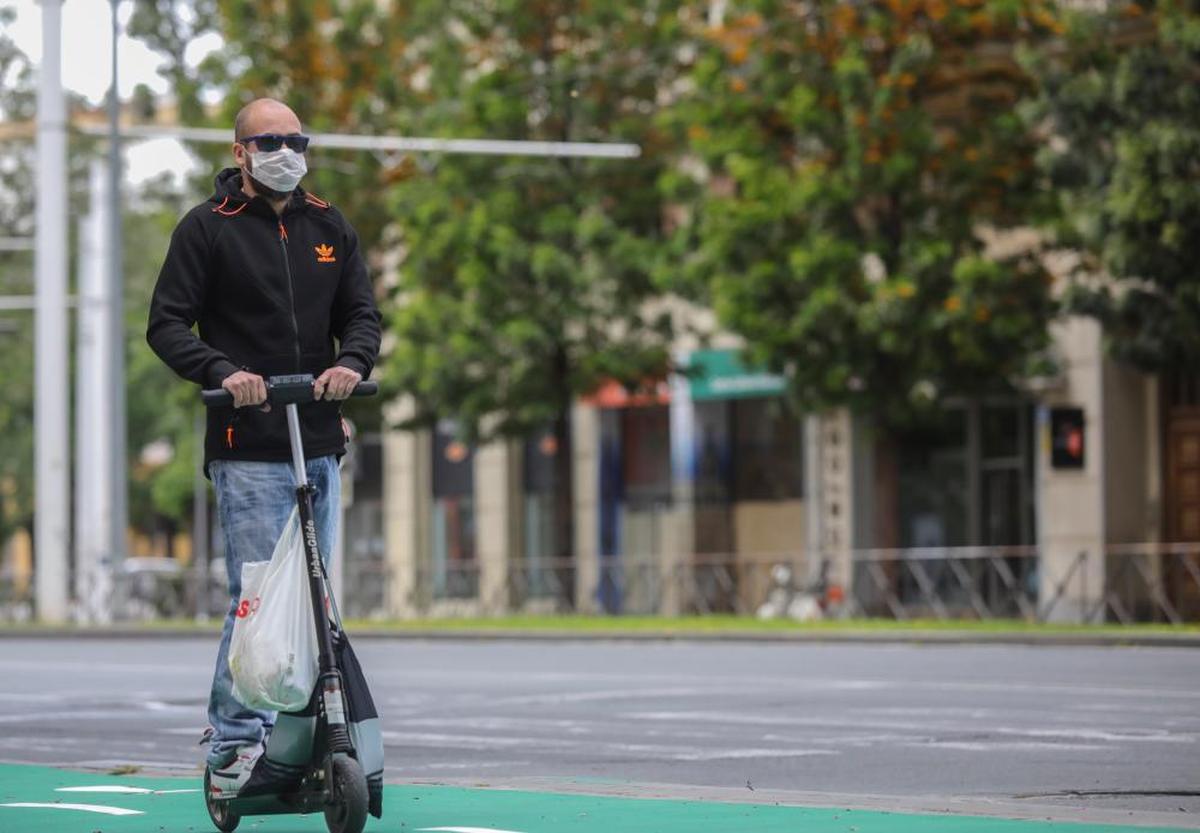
34 0 70 622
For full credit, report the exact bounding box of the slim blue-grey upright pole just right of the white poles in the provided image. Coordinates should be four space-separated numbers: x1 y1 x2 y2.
108 0 130 578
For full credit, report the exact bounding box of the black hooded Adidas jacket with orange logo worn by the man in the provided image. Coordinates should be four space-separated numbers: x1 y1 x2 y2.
146 168 379 471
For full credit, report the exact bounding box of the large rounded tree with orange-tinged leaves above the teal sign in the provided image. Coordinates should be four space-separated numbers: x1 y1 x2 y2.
665 0 1057 425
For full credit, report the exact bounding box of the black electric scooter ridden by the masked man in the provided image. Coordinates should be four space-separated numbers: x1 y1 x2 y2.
200 373 383 833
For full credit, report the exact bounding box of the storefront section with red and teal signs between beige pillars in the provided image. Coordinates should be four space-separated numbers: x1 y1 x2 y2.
383 349 805 616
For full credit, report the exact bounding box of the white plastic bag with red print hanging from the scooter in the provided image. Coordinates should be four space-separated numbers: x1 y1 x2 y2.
229 510 318 712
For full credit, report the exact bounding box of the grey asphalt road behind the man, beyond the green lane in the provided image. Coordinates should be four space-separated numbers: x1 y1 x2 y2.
0 639 1200 823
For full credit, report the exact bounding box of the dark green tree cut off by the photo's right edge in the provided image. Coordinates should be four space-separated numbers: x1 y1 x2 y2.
1030 0 1200 372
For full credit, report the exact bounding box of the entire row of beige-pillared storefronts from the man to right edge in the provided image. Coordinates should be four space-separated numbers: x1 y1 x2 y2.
382 318 1200 622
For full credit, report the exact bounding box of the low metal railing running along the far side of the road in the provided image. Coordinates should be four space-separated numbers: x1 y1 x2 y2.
7 544 1200 624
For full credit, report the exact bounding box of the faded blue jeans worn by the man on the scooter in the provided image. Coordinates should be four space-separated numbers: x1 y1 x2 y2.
208 455 342 767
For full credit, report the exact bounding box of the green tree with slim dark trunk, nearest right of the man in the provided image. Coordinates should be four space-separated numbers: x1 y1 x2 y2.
386 0 680 592
